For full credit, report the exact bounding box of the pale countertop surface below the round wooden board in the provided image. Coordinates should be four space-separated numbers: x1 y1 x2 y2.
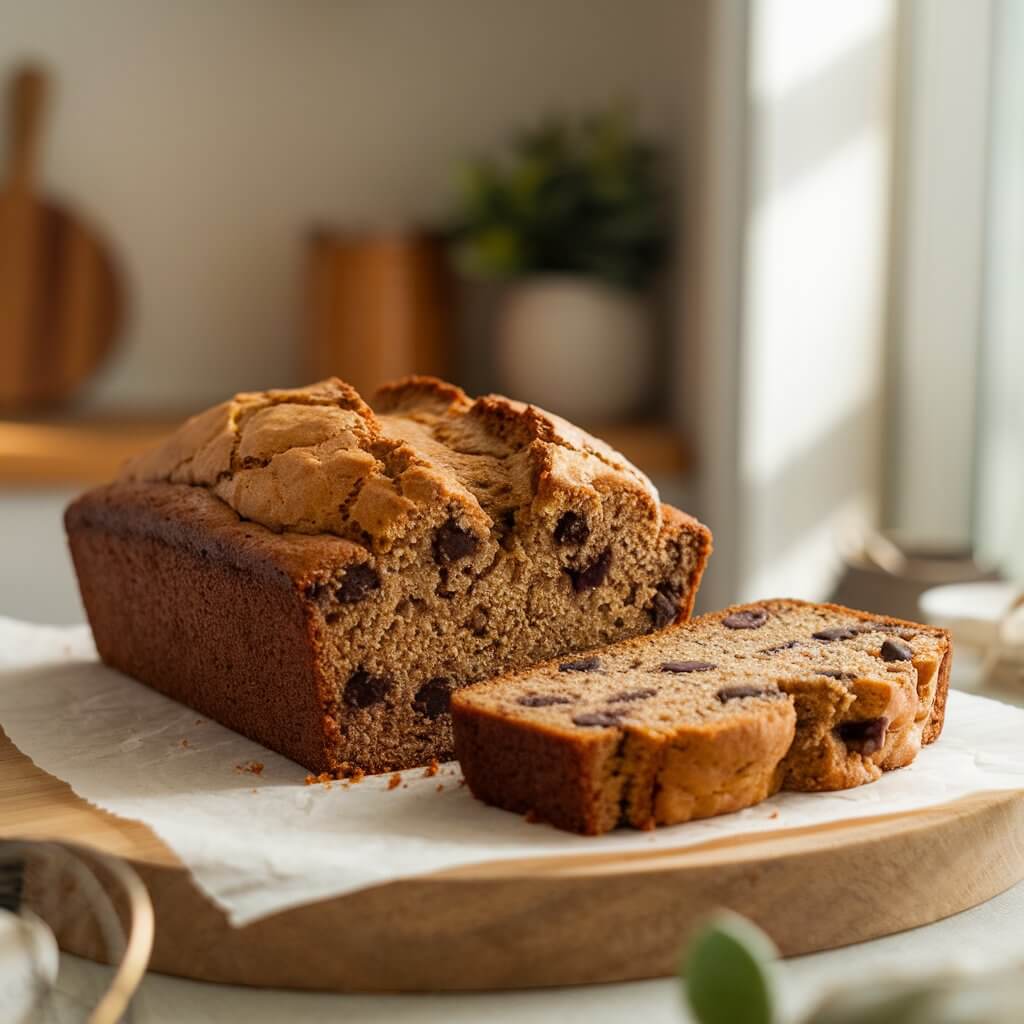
51 883 1024 1024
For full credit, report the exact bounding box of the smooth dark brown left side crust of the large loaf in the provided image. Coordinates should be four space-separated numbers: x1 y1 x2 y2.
68 484 335 772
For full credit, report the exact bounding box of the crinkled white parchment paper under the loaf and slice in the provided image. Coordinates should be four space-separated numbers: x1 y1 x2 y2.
0 617 1024 925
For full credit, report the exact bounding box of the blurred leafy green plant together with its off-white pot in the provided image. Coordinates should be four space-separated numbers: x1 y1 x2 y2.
452 112 668 422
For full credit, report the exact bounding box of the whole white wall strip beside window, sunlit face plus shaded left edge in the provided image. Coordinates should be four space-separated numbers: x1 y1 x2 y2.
689 0 896 608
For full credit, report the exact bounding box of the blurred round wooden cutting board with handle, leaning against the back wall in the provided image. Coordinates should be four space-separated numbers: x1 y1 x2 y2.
0 68 122 412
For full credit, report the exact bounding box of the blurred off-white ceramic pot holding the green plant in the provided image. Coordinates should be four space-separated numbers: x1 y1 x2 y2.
497 275 654 423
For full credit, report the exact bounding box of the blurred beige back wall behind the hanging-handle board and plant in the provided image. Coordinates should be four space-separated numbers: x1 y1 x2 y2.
0 0 700 407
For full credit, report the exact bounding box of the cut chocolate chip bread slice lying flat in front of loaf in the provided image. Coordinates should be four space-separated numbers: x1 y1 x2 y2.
453 600 951 834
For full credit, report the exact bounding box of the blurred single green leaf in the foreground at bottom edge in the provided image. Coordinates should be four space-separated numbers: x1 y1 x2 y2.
682 911 777 1024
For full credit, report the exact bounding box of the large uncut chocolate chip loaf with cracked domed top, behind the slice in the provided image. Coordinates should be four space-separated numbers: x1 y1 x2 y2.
66 378 711 773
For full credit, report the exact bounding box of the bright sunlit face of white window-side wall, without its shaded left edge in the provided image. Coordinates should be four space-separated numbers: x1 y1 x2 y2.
739 0 893 598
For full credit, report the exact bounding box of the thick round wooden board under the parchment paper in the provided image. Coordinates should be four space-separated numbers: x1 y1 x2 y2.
0 733 1024 992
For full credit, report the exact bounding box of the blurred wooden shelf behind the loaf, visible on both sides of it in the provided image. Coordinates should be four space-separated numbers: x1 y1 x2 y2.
0 417 690 486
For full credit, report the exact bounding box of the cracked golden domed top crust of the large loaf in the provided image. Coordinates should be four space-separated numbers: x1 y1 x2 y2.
122 377 662 550
